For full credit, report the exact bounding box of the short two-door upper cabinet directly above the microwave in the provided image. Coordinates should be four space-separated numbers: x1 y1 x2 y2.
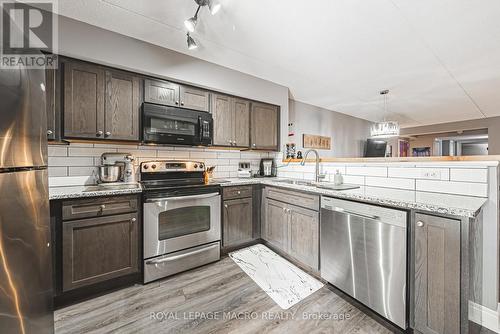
144 79 210 111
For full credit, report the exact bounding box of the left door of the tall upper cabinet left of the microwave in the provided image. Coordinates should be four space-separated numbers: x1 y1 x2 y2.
63 62 104 138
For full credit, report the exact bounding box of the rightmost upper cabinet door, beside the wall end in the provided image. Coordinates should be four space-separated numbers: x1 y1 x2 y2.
251 102 279 150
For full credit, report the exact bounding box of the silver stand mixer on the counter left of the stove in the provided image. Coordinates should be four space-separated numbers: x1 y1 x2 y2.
98 152 137 184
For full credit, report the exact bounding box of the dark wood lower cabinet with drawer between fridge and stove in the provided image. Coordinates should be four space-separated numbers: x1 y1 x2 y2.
60 195 141 293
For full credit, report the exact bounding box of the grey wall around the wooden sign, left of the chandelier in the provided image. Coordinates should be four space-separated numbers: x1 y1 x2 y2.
287 100 371 157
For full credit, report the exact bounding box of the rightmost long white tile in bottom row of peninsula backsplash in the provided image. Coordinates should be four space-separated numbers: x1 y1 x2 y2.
416 180 488 197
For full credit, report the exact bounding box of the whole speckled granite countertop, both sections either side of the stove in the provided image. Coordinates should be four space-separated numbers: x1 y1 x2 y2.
49 178 488 218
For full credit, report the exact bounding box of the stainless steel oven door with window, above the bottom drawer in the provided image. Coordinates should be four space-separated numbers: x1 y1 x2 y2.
144 192 221 259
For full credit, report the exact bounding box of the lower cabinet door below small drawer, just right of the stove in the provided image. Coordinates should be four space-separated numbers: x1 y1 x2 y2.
223 197 253 247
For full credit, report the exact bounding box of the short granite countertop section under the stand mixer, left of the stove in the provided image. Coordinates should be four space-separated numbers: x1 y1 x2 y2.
49 184 142 200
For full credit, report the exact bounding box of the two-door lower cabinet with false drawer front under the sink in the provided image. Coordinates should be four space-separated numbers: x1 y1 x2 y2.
262 189 319 270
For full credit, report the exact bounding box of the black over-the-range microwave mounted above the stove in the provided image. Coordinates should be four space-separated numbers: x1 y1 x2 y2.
142 103 213 146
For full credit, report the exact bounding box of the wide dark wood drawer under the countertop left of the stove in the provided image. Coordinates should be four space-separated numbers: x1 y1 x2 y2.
62 195 138 220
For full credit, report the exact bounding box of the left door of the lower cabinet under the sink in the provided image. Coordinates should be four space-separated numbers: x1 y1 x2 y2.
265 199 289 252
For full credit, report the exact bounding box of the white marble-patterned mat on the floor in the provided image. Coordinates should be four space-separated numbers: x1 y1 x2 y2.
229 244 323 310
